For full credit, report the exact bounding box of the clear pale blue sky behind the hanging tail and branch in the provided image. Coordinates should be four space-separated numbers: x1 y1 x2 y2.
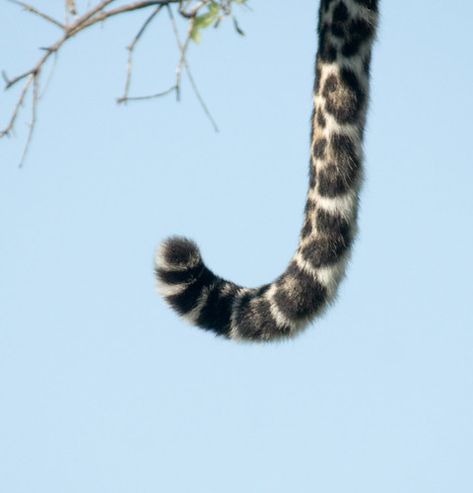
0 0 473 493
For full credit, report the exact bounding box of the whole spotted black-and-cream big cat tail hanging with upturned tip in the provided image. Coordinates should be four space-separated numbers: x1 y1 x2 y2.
156 0 378 341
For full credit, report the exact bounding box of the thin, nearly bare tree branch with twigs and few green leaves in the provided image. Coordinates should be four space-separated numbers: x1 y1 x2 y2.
0 0 244 165
